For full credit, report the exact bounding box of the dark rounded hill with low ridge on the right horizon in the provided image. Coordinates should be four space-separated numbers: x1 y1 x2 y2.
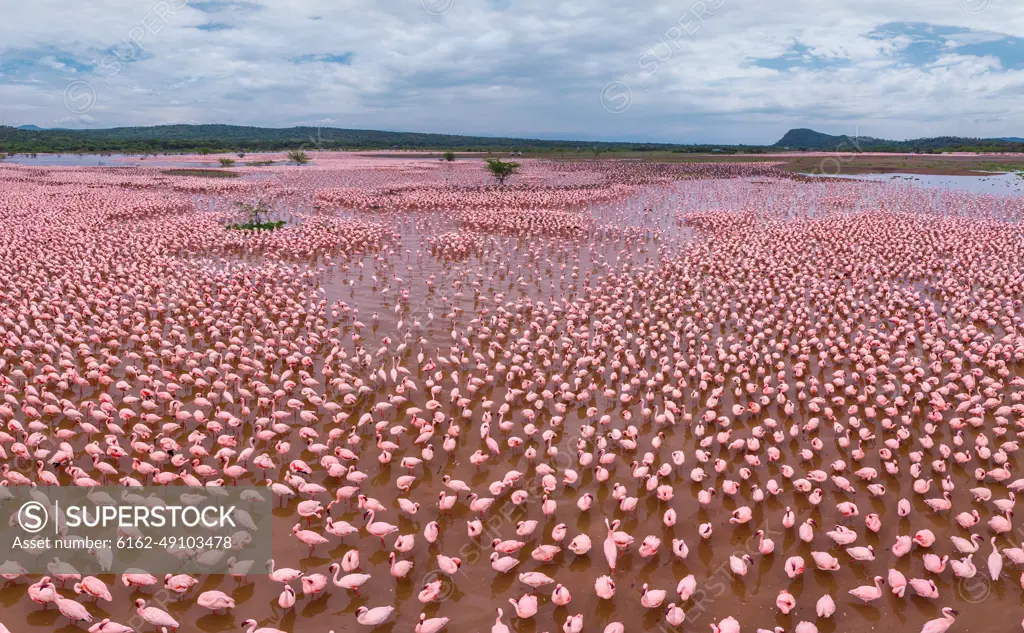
773 128 1024 154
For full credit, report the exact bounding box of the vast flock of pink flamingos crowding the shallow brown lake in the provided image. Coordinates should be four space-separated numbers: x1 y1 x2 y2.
0 155 1024 633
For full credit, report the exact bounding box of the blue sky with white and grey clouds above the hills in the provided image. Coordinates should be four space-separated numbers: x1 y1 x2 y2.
0 0 1024 143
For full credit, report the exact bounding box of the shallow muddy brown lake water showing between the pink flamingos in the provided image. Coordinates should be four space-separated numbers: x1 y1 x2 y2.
0 163 1022 633
